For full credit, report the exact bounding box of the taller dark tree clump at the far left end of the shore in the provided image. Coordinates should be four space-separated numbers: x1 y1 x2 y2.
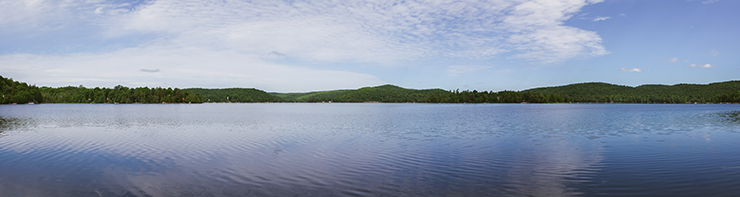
0 76 43 104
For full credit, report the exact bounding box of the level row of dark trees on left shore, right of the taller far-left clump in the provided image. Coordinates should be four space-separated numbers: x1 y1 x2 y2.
40 85 203 103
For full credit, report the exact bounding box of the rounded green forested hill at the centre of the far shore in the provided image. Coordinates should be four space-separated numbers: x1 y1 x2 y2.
272 85 447 103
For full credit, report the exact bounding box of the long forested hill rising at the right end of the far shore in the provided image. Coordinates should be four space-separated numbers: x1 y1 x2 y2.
522 81 740 103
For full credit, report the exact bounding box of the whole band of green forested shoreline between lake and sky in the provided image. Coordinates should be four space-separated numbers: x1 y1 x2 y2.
0 76 740 104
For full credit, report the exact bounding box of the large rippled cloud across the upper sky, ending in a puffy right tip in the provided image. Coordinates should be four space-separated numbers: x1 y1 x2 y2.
98 0 608 63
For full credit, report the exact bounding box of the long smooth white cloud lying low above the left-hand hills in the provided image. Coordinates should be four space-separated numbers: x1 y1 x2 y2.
0 47 386 92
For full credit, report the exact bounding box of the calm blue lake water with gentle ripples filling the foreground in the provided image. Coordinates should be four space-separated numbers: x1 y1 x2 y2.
0 103 740 196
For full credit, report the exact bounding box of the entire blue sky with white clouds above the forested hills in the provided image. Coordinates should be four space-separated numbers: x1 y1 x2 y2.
0 0 740 92
